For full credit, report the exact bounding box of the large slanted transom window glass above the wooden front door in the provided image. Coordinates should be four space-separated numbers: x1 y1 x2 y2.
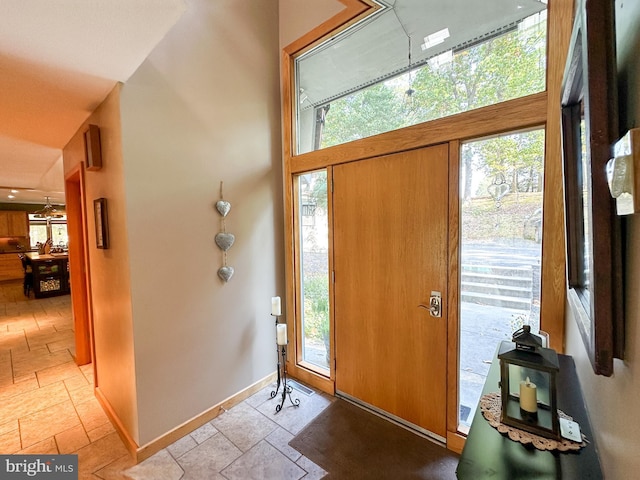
295 0 547 154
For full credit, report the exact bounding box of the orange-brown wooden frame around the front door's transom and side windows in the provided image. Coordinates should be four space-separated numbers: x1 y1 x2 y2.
281 0 573 451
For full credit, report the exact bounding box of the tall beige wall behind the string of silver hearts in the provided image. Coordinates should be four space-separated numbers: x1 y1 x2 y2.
121 0 284 445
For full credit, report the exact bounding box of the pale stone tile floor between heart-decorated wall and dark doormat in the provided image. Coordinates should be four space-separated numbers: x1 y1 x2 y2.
124 385 333 480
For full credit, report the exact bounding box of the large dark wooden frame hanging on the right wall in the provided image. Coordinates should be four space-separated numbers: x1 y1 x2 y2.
562 2 624 376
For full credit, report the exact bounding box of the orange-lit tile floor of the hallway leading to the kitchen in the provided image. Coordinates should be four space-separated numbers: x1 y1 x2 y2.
0 282 129 478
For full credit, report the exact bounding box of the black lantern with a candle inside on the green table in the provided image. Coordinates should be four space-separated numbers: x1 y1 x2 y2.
498 325 560 439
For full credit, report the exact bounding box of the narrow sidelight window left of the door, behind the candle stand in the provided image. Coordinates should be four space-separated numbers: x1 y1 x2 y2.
296 170 330 374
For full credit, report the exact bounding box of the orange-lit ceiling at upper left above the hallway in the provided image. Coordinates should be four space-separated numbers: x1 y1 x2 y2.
0 0 188 204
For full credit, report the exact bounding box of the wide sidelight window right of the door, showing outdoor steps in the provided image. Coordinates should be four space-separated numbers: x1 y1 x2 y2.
459 130 544 431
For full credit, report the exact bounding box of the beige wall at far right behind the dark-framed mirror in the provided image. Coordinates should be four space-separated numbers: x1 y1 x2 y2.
566 2 640 479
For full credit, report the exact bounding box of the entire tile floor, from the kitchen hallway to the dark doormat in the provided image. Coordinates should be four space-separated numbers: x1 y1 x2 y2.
0 282 333 480
